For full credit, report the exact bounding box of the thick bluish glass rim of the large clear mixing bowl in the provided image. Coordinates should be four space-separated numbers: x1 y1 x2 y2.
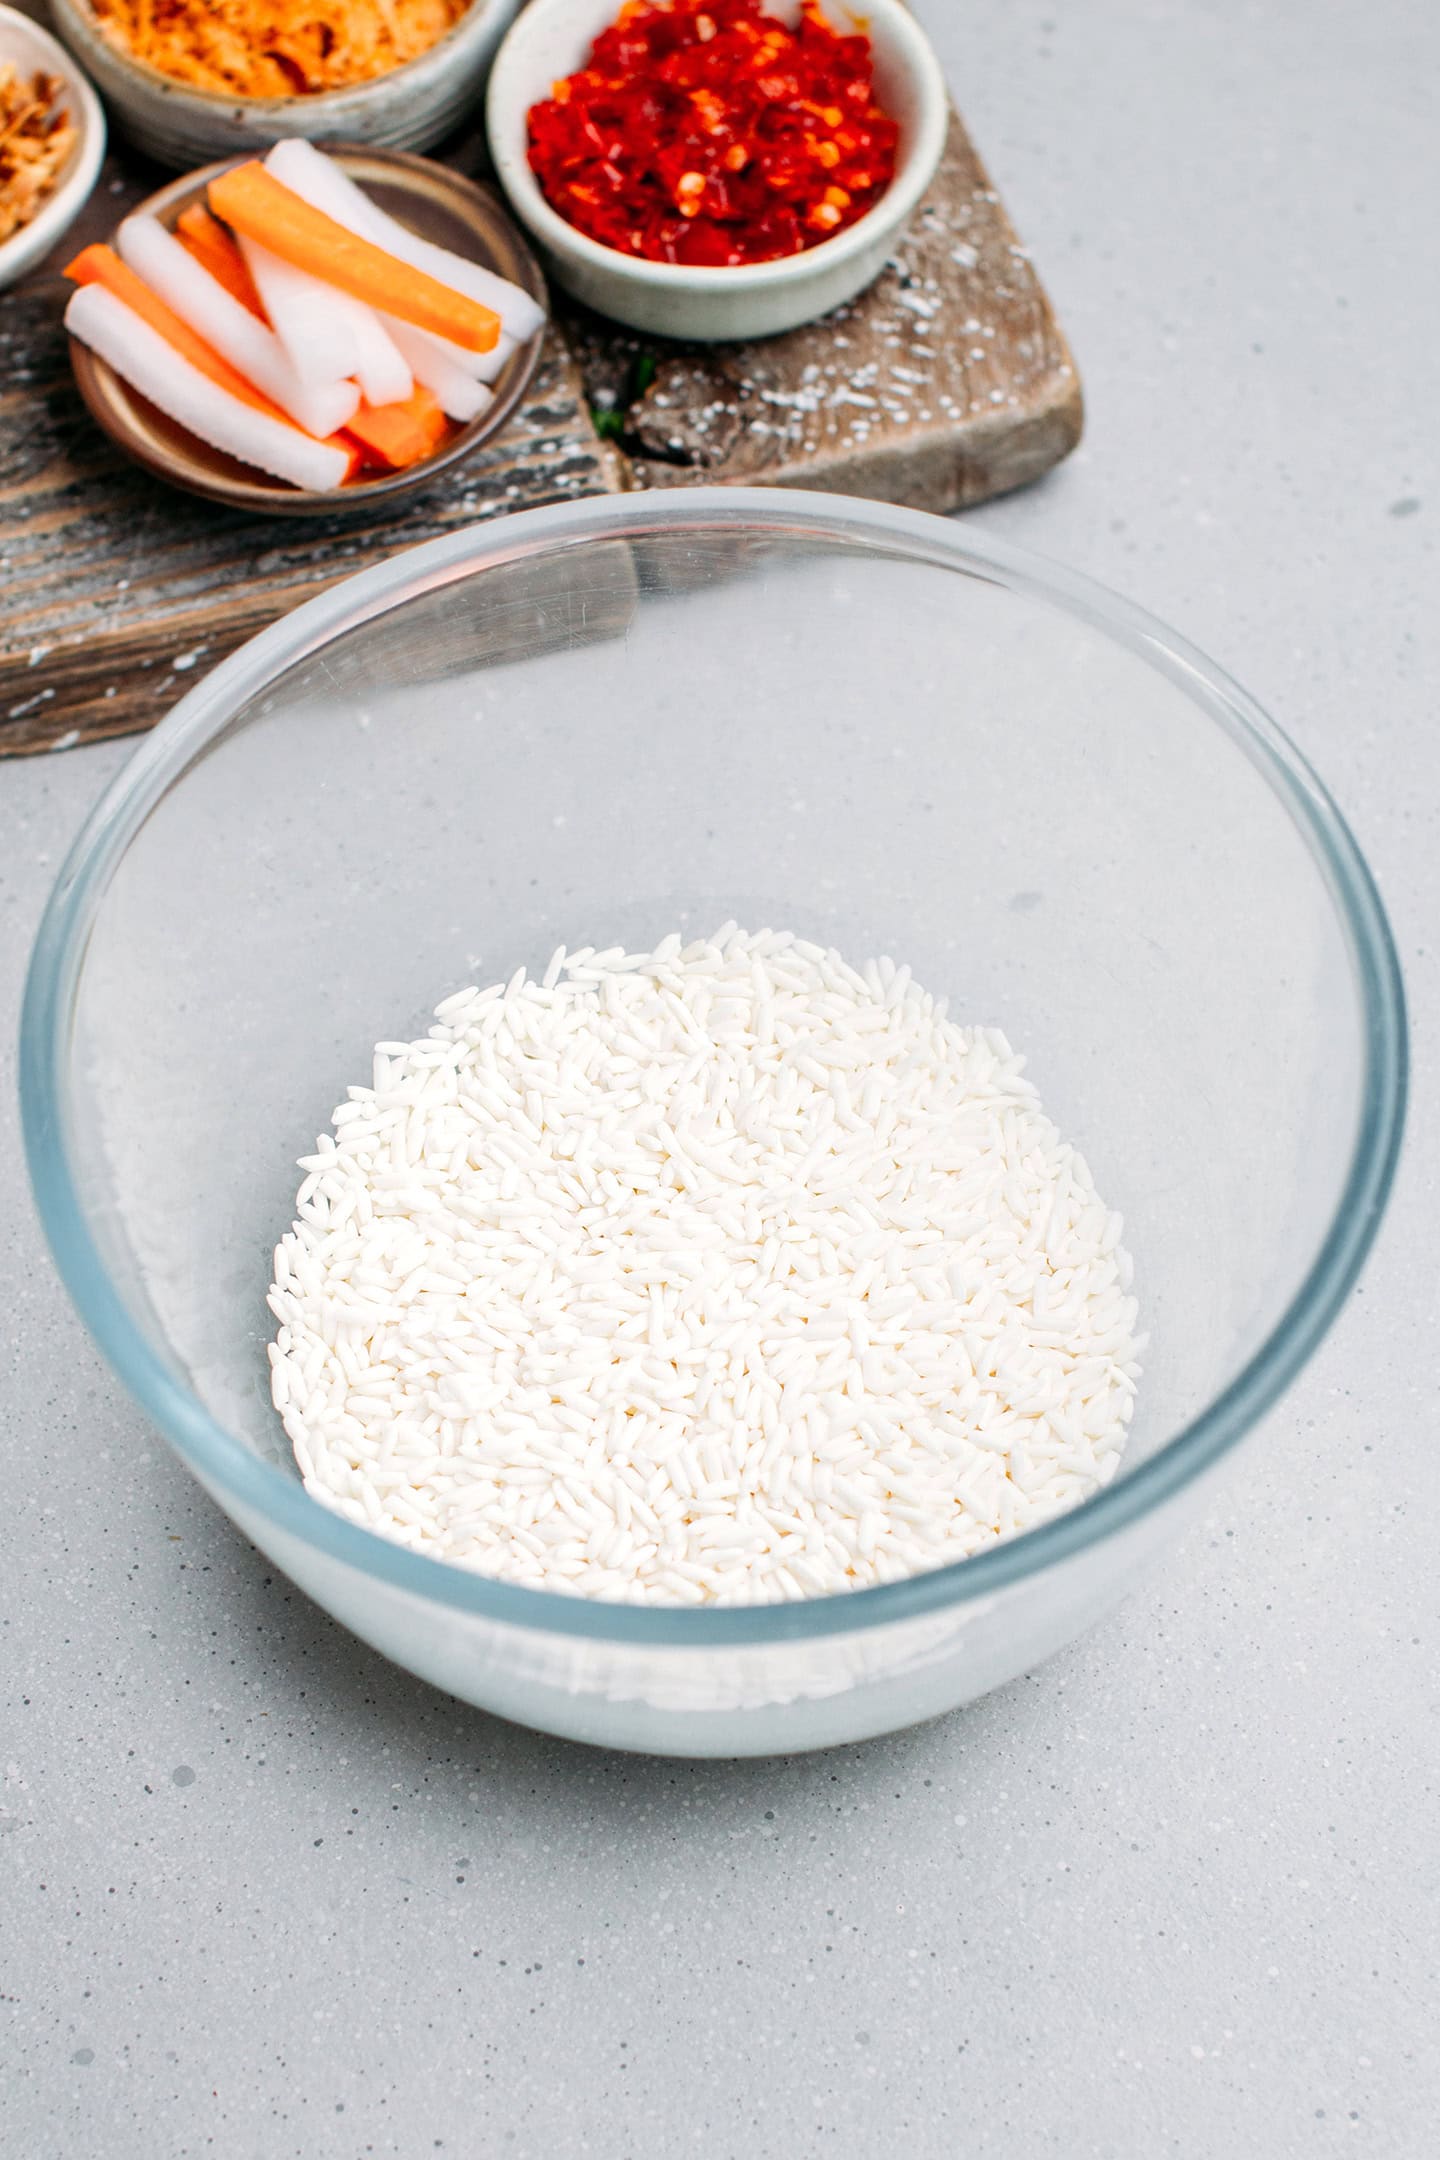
19 488 1408 1650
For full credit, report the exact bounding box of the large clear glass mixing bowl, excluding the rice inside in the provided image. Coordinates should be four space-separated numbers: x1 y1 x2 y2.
22 488 1405 1754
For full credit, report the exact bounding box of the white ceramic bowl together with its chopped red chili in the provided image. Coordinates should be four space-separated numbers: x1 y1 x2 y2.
488 0 948 339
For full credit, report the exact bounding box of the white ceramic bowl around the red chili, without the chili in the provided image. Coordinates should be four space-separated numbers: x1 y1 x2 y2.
486 0 950 341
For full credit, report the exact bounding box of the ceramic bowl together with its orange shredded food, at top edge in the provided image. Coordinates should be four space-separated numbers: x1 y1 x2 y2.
52 0 518 168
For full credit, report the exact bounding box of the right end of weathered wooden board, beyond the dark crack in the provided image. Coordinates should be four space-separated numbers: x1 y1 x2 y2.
566 117 1082 510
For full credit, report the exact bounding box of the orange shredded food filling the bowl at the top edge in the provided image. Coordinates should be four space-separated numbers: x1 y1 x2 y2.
93 0 471 97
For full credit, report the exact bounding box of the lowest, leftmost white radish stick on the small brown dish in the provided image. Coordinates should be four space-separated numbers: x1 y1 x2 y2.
65 285 350 492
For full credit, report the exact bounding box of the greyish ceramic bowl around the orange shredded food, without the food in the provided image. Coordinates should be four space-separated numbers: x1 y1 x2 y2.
50 0 518 171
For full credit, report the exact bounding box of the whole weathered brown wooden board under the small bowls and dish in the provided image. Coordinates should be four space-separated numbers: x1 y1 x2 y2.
0 117 1082 756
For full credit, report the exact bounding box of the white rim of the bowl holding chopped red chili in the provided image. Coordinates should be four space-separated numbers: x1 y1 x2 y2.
486 0 950 294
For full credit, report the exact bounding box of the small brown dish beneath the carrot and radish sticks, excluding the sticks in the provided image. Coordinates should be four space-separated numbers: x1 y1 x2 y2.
69 145 546 516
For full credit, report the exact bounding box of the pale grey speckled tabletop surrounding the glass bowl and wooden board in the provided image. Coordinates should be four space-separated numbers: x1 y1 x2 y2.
0 0 1440 2160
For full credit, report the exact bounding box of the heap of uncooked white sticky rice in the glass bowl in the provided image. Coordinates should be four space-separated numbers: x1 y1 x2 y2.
270 924 1140 1605
